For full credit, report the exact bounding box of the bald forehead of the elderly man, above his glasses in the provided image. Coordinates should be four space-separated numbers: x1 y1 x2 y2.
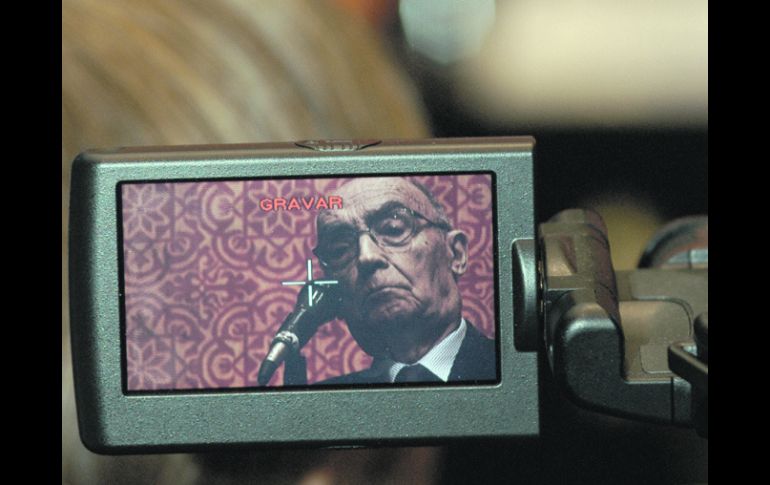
318 177 435 223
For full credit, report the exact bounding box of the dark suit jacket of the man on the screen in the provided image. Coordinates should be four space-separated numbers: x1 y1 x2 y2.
316 320 497 385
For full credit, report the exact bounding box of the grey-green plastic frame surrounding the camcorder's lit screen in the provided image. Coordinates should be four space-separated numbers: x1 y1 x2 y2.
70 137 539 454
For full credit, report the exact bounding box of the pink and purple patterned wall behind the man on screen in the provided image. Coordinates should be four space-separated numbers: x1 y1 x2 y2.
122 174 495 391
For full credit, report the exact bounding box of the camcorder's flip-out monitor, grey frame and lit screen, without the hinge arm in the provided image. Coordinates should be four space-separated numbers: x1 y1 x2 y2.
70 137 542 453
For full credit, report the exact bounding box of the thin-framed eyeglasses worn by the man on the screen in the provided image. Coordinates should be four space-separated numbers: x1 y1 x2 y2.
313 207 452 270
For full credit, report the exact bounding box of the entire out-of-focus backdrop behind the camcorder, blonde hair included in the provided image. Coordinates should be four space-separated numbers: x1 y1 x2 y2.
62 0 708 484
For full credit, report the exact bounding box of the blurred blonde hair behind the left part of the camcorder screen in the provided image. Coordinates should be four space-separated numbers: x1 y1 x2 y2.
62 0 433 484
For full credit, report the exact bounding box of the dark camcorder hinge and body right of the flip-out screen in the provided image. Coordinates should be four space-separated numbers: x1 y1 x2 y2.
528 209 708 437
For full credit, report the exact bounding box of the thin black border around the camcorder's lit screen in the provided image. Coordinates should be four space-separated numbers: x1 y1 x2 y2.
115 170 502 397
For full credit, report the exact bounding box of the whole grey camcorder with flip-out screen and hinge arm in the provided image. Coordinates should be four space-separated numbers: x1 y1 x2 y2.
69 137 708 454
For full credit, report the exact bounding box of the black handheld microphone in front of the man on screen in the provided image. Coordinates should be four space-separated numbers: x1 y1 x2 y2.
257 281 340 386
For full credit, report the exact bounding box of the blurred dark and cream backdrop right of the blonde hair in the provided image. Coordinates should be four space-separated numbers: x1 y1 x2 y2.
352 0 708 269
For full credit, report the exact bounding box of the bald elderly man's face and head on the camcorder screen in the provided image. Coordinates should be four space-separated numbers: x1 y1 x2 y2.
317 178 467 355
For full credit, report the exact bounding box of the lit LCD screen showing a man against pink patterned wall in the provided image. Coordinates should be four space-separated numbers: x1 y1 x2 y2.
117 172 499 393
